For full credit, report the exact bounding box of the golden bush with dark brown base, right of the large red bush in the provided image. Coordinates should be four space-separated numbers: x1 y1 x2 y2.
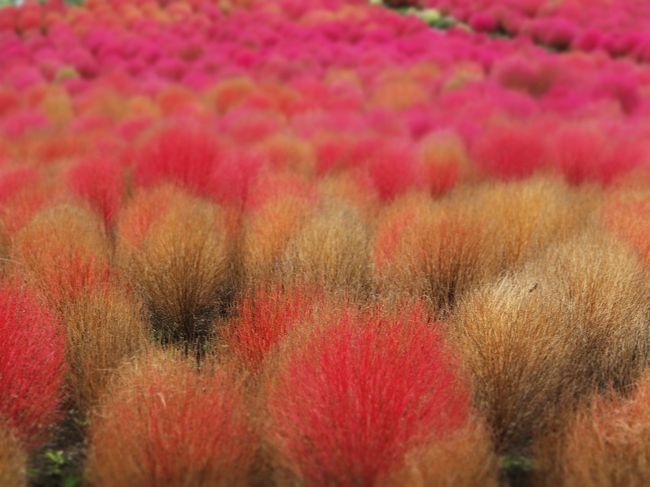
452 274 576 451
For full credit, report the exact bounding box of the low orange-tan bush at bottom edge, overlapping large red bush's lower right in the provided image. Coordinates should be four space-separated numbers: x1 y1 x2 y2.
384 421 499 487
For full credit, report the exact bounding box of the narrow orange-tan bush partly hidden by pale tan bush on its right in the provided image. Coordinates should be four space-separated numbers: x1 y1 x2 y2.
241 196 314 289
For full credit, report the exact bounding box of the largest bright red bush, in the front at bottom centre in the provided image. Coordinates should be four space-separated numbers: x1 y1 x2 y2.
268 312 469 486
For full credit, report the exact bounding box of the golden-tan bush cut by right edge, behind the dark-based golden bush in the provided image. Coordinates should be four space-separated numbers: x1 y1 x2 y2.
534 227 650 388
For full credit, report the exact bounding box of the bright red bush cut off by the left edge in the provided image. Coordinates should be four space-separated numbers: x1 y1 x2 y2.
0 284 65 447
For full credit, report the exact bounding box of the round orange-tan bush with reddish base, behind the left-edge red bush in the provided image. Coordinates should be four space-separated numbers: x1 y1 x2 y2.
10 205 111 312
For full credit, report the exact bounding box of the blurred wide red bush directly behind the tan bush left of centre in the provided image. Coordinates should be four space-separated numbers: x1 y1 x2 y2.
135 126 222 196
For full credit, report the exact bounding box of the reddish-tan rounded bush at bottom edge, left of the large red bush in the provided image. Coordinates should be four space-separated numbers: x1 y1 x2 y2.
86 353 256 487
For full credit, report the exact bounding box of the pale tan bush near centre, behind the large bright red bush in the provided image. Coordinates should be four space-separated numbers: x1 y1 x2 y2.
281 205 370 296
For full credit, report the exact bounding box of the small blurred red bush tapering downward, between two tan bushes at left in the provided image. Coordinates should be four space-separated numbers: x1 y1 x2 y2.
68 160 124 228
